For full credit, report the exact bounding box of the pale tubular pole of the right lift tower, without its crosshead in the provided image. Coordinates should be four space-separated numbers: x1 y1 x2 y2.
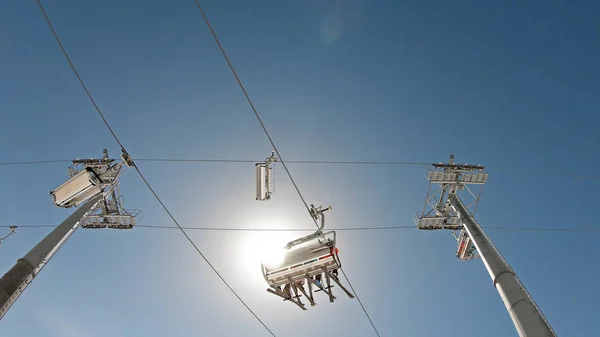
448 194 556 337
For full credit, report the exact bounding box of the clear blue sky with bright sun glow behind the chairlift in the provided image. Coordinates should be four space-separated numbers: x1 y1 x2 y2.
0 0 600 337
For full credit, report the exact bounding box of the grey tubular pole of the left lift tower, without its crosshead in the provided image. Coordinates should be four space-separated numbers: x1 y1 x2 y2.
0 193 103 320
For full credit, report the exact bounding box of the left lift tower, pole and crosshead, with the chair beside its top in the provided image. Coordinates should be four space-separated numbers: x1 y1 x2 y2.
0 150 139 320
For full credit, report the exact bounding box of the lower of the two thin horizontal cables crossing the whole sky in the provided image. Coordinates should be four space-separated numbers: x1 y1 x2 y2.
0 224 600 233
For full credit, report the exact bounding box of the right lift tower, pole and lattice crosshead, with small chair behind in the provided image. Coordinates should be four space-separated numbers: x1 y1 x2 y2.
415 156 556 337
